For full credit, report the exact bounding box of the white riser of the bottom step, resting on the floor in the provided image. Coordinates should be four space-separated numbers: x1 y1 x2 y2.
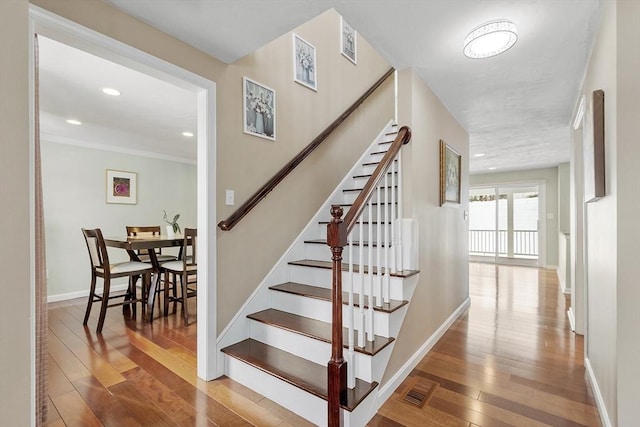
225 357 376 427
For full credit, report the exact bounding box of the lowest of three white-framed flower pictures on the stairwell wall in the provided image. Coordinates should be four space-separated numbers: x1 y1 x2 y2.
242 77 276 141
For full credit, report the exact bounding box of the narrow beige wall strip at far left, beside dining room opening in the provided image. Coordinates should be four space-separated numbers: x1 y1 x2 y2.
0 0 33 426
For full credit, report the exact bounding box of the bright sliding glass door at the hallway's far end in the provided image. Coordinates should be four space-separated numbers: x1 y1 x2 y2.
469 183 541 266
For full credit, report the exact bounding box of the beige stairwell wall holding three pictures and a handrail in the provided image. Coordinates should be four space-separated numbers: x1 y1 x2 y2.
33 0 394 331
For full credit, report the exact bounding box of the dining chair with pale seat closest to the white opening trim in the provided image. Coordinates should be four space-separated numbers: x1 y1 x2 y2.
161 228 198 325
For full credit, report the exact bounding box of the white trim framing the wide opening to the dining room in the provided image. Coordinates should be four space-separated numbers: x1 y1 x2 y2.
29 4 217 380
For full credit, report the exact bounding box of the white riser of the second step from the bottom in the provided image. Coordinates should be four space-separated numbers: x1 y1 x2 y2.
251 321 380 382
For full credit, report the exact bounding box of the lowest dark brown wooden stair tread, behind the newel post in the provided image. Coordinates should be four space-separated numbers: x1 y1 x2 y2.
222 338 378 411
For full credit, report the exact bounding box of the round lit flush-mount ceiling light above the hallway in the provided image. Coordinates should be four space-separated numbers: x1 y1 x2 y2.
464 21 518 59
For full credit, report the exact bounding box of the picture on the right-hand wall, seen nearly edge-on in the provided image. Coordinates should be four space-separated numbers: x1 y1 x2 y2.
582 90 605 203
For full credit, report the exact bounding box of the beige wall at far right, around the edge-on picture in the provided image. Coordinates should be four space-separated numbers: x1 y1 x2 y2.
582 0 640 427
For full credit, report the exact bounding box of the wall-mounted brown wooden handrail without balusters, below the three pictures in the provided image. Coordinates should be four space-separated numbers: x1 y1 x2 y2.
218 68 395 231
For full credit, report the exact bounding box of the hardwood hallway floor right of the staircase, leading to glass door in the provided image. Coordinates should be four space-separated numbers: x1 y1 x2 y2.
370 263 601 427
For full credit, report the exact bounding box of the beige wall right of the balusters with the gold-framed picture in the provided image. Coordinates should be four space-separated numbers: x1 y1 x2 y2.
383 69 469 383
